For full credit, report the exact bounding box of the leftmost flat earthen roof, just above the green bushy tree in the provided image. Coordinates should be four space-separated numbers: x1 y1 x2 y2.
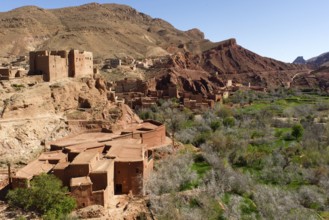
14 160 54 179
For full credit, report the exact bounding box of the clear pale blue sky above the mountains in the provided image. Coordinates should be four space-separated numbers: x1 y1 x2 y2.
0 0 329 62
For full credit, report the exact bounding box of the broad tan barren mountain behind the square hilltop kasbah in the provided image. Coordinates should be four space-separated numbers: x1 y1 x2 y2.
0 3 214 58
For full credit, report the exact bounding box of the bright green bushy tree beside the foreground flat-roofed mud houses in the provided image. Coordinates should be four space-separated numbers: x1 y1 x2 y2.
7 174 76 219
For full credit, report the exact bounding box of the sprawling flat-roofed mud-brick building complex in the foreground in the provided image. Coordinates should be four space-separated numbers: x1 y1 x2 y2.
12 120 171 207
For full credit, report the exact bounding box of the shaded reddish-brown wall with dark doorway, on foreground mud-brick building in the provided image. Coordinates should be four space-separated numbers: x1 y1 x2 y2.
114 161 143 195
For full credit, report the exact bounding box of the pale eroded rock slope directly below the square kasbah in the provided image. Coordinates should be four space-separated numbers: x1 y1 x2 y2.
0 77 139 164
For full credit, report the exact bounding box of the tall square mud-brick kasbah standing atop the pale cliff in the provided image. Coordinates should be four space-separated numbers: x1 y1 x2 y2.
29 50 93 82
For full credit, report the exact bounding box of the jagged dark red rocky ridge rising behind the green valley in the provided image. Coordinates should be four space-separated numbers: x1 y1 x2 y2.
147 39 308 95
